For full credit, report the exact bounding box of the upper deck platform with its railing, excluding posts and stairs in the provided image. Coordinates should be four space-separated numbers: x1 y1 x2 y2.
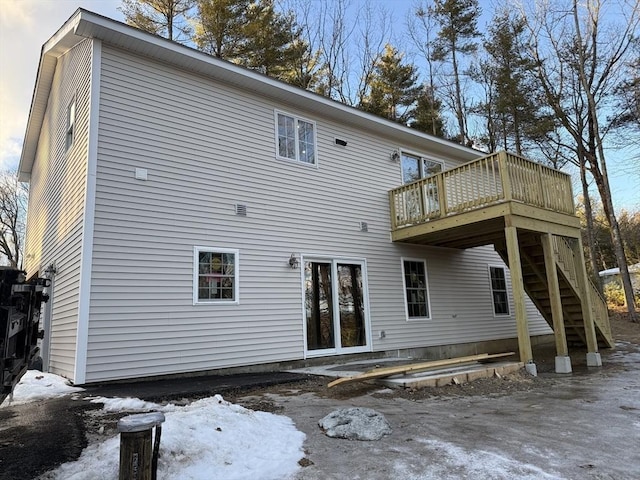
389 152 580 248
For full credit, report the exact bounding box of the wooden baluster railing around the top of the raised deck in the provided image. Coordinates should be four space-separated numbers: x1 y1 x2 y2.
389 152 575 230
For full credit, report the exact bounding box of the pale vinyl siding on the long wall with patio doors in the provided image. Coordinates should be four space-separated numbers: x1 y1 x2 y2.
81 46 548 382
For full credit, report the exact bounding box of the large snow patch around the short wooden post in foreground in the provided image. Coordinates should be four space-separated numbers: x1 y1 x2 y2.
44 395 305 480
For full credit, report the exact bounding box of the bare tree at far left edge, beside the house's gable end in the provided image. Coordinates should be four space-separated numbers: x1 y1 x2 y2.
0 172 28 267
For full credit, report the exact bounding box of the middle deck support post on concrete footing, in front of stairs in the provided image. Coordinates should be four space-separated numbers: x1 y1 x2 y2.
541 233 571 373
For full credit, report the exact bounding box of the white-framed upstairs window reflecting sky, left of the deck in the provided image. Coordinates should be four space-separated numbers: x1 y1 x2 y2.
276 112 316 165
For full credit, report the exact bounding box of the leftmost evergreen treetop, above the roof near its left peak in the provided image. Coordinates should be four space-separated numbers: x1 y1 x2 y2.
119 0 194 40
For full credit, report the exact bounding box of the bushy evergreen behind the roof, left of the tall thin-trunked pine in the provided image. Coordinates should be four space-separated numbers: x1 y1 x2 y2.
360 44 422 124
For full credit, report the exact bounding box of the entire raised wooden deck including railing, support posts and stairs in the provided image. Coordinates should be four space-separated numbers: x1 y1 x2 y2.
389 152 614 373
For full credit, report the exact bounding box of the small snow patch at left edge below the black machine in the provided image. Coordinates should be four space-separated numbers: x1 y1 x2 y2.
0 370 83 408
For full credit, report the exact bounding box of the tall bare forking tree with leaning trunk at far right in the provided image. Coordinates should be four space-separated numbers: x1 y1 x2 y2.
523 0 640 321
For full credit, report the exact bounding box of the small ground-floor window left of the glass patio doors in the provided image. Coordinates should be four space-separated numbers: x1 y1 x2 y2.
193 247 238 303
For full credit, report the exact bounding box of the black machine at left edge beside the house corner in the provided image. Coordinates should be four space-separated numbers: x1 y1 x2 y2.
0 267 49 404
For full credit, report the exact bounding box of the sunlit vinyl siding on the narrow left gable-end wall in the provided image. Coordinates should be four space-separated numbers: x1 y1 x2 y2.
25 40 91 379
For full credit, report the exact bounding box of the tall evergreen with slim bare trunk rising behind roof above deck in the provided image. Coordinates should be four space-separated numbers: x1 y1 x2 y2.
433 0 480 144
